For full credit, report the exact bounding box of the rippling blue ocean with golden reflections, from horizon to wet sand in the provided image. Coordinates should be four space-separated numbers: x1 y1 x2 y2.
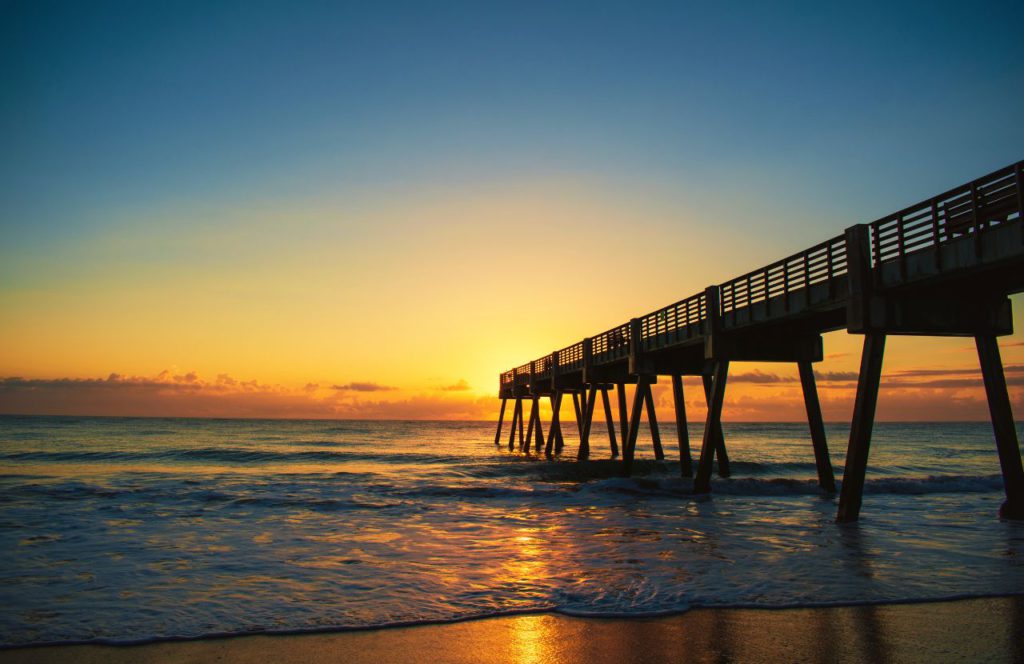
0 416 1024 646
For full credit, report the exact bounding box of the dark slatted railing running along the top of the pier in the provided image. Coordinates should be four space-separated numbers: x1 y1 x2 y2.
500 162 1024 388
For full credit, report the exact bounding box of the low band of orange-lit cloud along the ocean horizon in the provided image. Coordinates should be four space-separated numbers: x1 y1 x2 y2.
0 354 1024 422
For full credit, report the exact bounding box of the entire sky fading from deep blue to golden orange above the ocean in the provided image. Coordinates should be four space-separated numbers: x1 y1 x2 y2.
0 0 1024 421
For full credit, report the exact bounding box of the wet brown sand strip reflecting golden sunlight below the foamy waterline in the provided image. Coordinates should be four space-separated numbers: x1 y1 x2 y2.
0 596 1024 664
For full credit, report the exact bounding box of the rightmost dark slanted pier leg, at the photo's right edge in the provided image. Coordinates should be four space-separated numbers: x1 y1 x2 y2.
975 335 1024 520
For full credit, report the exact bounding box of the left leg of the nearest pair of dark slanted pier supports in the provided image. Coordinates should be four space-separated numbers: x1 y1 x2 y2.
836 332 886 524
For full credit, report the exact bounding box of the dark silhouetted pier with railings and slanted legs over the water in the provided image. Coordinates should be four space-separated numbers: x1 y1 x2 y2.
495 157 1024 522
